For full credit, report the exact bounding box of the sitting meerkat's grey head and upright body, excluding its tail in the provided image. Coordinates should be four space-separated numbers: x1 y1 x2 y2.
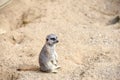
39 34 60 73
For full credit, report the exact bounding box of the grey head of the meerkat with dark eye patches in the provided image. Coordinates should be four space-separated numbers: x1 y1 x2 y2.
46 34 59 46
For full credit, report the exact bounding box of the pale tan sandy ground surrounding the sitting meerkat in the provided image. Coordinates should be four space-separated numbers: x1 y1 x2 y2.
0 0 120 80
